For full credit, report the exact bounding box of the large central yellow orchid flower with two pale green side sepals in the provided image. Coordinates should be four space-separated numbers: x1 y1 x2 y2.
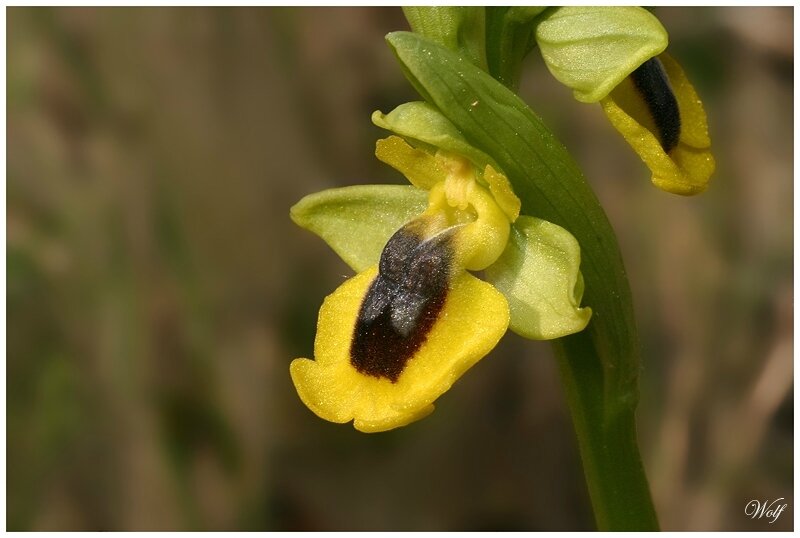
290 123 591 432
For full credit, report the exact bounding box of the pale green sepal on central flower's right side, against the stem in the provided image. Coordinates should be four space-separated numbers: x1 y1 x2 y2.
486 216 592 340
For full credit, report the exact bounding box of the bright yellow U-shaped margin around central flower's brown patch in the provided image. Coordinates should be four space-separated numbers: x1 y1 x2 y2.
290 260 509 432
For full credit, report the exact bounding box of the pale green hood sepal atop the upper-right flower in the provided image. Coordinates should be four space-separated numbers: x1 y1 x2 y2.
536 7 667 103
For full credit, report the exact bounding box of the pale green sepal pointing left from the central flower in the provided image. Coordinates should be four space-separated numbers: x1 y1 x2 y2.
290 185 428 271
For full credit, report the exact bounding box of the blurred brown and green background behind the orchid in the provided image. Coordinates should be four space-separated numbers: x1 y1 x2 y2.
6 8 794 530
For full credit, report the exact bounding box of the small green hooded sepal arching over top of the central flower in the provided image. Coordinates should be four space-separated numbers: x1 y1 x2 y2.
372 101 500 171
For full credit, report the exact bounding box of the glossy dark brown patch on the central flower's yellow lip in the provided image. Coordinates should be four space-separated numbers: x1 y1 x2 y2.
350 222 452 383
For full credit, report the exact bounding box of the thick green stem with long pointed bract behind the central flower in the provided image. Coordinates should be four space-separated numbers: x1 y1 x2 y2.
387 32 658 530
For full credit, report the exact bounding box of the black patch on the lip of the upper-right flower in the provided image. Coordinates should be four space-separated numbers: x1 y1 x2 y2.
631 58 681 153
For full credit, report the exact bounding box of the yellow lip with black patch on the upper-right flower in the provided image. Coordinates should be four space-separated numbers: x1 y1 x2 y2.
600 53 715 195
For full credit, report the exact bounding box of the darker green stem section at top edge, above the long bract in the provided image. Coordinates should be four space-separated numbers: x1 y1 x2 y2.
486 6 547 90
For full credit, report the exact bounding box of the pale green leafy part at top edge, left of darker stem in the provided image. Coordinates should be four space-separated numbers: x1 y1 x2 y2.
403 6 486 70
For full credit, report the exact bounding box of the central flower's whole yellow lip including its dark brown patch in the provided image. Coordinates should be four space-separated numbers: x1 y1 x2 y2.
290 184 510 432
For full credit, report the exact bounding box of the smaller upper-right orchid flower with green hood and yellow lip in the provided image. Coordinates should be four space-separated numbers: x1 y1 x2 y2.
535 6 715 195
